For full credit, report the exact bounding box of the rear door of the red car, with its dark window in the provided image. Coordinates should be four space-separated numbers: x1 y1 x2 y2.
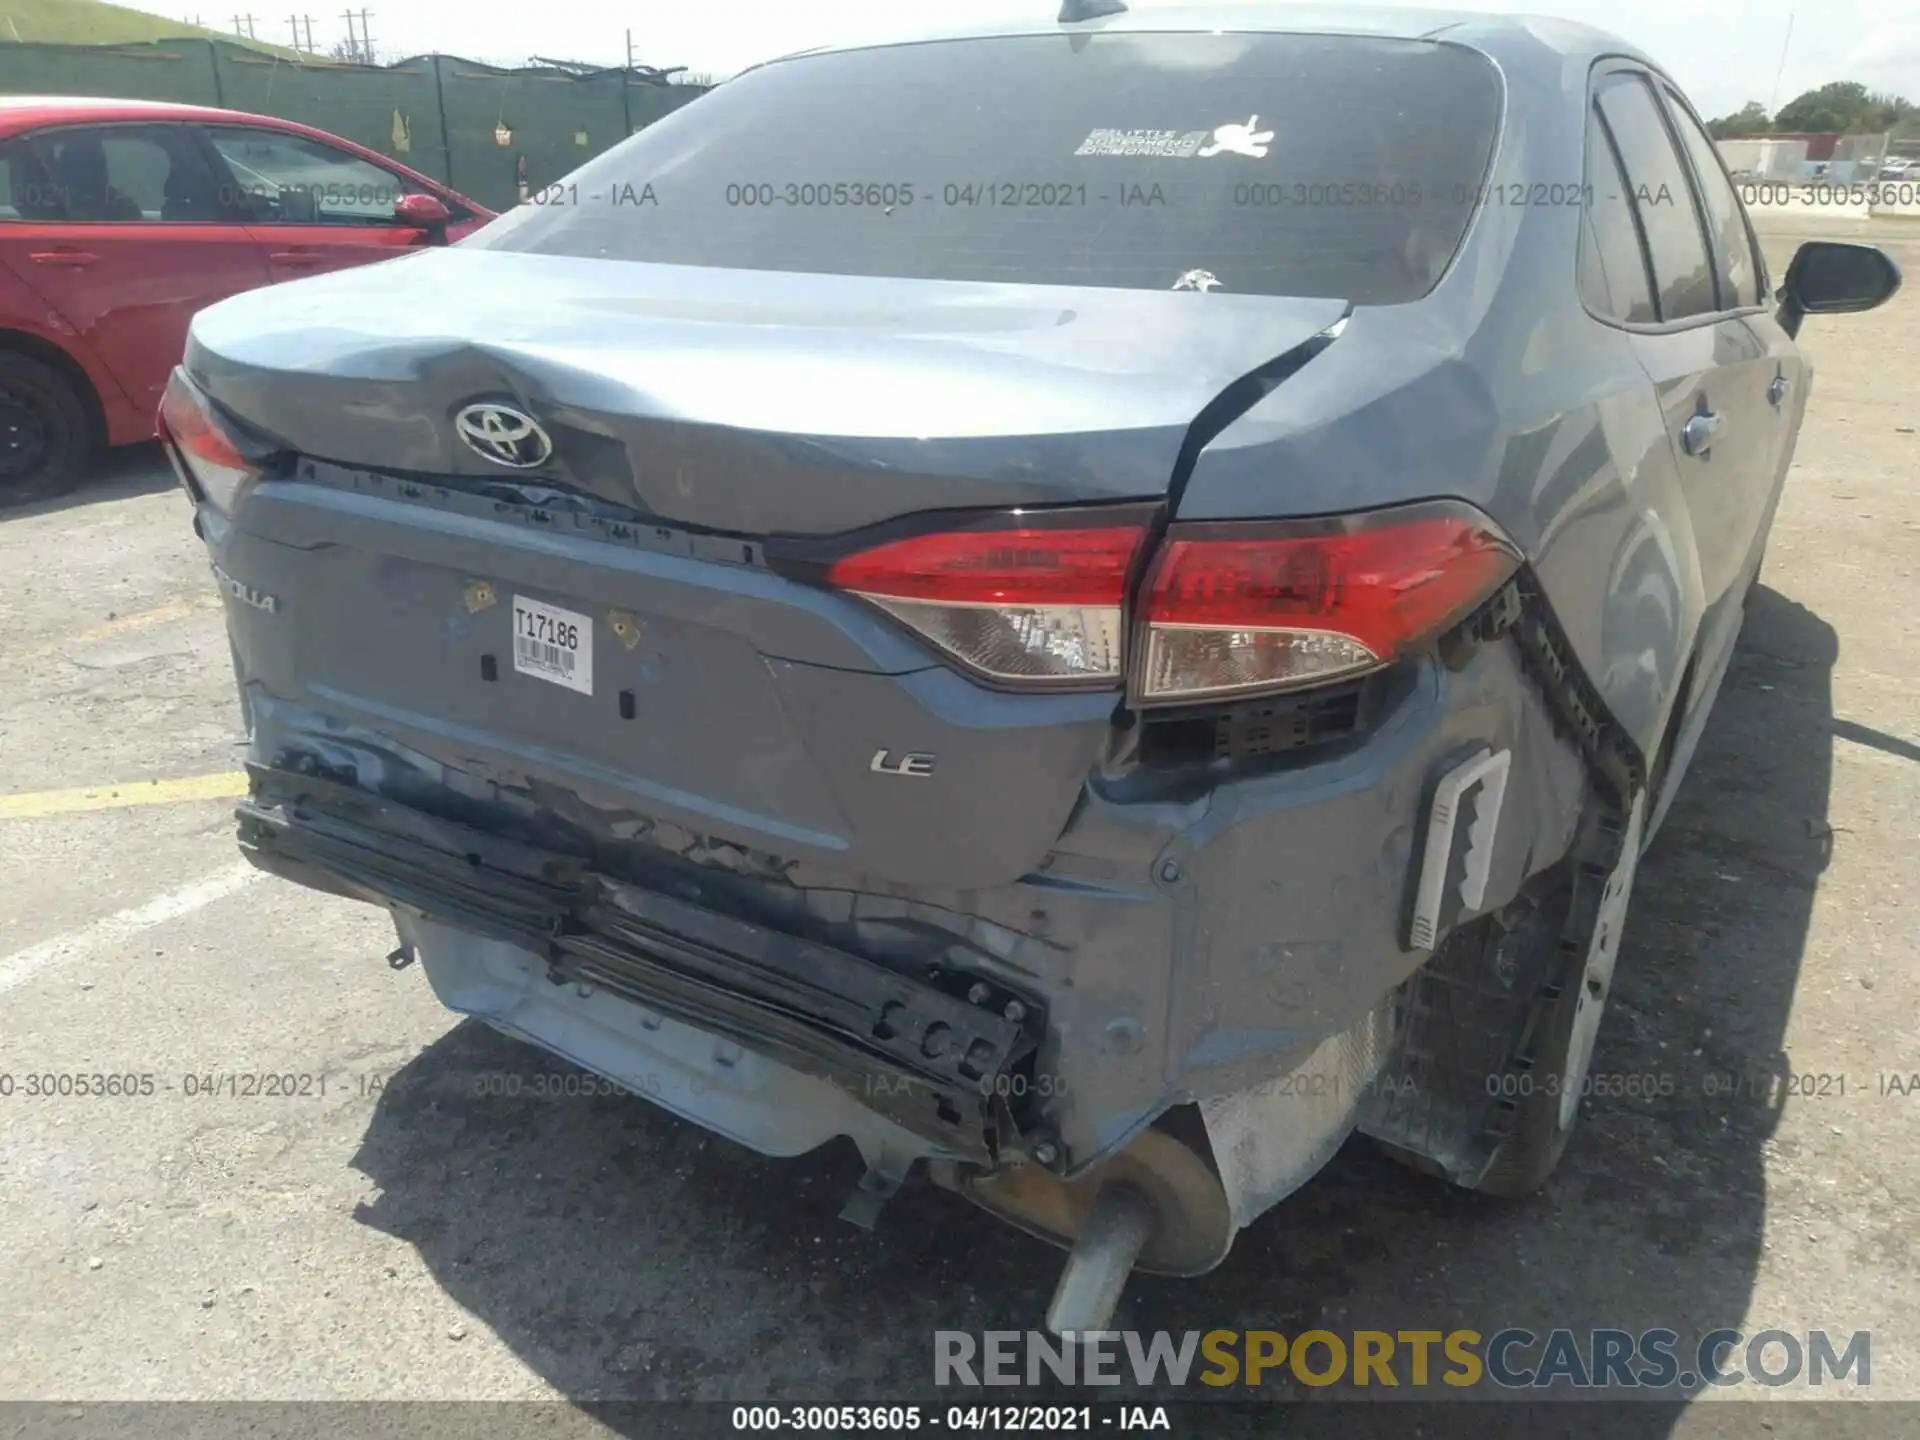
0 123 267 415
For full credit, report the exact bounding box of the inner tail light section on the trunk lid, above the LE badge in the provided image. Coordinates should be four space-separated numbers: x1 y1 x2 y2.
828 516 1146 684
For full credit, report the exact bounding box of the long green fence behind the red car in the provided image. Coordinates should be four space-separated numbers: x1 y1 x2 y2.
0 36 705 209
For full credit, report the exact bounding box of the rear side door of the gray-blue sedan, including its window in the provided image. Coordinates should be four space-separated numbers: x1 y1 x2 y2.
1594 67 1780 670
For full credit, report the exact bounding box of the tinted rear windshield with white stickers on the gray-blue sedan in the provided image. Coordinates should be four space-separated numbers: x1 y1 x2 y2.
468 33 1500 303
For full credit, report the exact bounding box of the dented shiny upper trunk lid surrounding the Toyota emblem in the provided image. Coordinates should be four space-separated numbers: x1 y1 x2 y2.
188 250 1346 536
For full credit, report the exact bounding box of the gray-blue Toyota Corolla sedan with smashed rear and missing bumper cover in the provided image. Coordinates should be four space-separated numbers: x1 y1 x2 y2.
163 0 1899 1331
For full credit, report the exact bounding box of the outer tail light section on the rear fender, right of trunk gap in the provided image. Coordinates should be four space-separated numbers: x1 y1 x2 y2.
1135 505 1519 705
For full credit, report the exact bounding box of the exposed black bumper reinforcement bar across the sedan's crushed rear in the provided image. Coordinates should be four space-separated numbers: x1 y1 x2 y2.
236 766 1046 1165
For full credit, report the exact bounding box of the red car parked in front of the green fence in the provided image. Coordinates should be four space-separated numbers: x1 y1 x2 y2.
0 96 493 505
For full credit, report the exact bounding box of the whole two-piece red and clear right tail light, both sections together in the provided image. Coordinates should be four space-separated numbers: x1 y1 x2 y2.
814 501 1519 705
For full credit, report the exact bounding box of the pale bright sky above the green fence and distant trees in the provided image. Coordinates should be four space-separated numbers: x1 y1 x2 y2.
187 0 1920 117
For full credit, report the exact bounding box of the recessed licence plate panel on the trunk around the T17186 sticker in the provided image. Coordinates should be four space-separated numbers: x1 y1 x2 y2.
280 545 847 852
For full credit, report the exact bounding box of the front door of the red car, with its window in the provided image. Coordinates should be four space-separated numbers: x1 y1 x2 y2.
202 125 461 280
